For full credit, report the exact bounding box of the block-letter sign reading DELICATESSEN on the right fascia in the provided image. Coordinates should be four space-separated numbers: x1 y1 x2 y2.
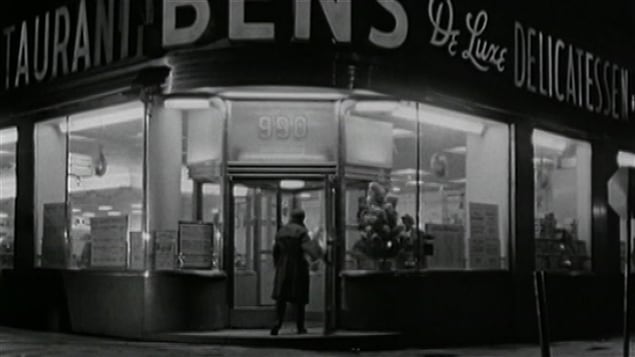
514 22 631 120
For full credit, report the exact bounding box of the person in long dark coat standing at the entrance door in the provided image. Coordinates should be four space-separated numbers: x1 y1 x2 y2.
271 209 310 336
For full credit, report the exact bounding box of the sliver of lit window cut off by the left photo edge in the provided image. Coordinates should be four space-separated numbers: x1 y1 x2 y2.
0 128 18 269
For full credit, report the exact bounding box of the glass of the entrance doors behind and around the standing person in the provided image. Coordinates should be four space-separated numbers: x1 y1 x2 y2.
233 180 328 321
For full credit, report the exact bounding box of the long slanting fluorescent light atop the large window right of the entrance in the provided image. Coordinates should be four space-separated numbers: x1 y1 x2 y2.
392 104 485 135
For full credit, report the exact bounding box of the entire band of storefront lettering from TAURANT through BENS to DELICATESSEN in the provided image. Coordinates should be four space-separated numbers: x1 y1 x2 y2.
0 0 633 120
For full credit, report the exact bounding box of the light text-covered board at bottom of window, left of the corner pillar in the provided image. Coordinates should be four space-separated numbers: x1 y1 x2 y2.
90 216 128 268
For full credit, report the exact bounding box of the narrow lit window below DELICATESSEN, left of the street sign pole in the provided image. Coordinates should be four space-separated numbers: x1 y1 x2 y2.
532 130 591 270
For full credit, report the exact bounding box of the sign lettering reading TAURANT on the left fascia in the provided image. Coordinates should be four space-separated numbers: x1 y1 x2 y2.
0 0 152 90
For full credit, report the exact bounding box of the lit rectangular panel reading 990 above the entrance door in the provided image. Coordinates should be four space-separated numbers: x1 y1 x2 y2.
228 101 337 164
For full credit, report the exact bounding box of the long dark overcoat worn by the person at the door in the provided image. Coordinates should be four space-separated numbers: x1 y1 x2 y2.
271 222 310 304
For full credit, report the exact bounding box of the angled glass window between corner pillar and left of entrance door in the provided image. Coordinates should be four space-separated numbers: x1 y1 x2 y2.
148 97 225 270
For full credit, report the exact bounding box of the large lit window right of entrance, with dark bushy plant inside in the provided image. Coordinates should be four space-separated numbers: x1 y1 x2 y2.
345 103 509 269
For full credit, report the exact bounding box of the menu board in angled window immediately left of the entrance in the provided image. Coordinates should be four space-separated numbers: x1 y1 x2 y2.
178 222 214 269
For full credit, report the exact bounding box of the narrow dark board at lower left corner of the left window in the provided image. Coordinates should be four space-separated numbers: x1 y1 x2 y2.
42 202 70 268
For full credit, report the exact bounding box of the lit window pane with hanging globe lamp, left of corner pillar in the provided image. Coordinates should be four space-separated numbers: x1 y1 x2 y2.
68 102 144 269
